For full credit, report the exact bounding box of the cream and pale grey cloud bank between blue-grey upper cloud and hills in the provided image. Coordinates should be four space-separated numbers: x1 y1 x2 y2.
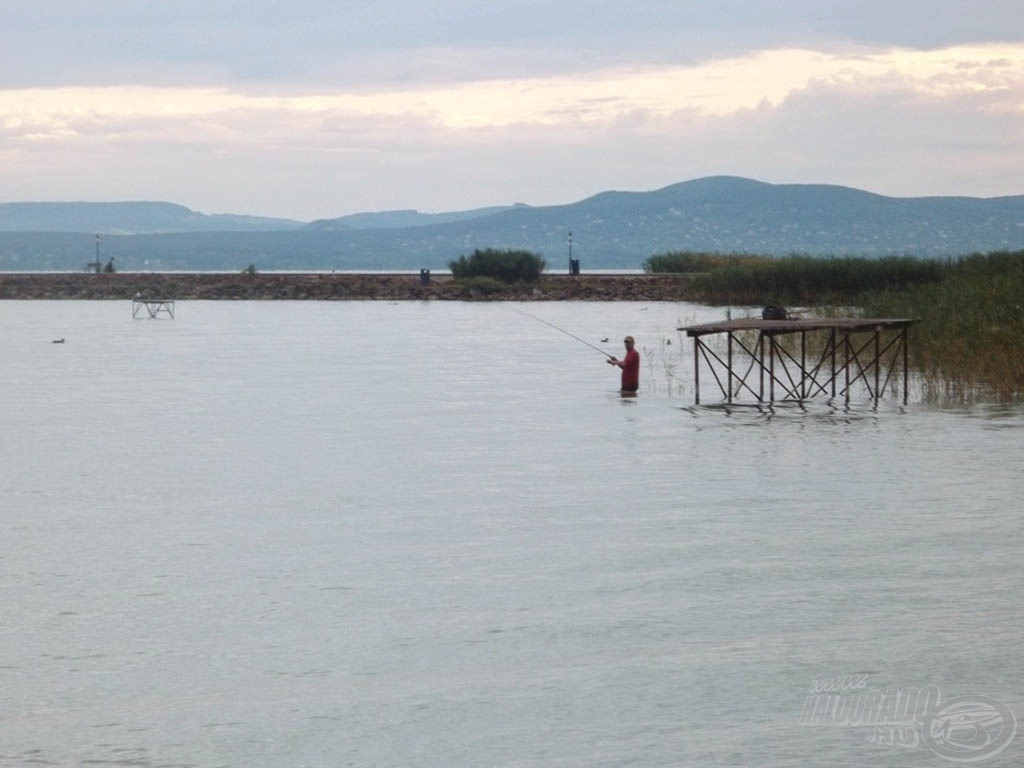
0 38 1024 219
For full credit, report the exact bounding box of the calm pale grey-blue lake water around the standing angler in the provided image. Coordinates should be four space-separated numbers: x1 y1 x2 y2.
0 301 1024 768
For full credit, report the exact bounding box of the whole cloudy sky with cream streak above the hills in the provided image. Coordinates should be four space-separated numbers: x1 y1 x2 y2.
0 0 1024 221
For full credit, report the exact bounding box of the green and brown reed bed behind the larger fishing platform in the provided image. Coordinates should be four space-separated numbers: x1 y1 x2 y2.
644 251 1024 402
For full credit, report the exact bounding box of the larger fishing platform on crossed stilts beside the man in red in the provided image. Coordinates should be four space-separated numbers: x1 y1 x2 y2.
678 317 913 404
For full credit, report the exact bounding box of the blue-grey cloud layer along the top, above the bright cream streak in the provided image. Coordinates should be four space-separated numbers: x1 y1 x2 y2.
0 0 1024 89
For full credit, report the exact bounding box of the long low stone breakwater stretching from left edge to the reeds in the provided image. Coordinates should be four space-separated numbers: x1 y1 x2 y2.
0 272 693 301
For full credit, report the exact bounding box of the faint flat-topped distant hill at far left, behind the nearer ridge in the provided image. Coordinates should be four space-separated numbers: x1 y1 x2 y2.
0 203 304 234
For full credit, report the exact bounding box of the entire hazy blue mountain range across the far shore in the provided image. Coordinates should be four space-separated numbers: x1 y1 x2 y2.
0 176 1024 270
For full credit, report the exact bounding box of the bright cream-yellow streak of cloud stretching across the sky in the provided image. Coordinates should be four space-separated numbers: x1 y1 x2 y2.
6 46 1024 132
